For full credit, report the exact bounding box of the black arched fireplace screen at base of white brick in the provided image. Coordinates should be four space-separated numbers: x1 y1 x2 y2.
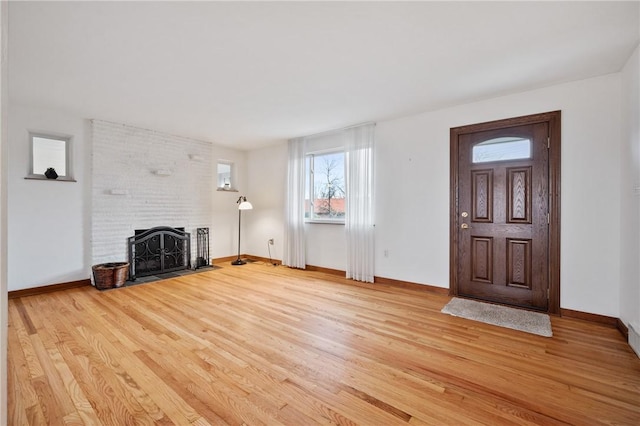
127 226 191 281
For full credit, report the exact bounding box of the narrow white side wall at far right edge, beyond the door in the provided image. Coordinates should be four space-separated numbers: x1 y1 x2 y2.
620 47 640 330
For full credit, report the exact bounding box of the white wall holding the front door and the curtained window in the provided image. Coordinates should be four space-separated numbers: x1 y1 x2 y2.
249 74 622 317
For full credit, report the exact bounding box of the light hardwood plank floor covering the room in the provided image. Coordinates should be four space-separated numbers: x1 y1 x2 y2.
8 263 640 426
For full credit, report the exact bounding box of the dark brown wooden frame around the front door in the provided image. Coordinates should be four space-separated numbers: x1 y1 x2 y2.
449 111 561 315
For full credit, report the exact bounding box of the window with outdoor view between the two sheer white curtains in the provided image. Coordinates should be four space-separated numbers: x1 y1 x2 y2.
304 151 346 223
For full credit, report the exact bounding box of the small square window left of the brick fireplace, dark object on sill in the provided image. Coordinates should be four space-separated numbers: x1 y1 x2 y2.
29 133 72 180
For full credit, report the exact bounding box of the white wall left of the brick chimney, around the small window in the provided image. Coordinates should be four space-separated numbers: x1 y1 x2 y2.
7 105 90 290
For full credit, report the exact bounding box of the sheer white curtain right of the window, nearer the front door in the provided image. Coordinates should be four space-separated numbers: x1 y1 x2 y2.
345 124 375 282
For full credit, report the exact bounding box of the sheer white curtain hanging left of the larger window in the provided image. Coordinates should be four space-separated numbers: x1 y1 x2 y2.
282 138 306 269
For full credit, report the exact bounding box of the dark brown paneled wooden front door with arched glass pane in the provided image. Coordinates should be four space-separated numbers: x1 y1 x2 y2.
451 115 559 312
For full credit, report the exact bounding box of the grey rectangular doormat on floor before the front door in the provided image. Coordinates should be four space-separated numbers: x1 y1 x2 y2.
441 297 553 337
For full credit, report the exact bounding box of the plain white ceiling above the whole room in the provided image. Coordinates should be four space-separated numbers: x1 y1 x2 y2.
9 1 640 149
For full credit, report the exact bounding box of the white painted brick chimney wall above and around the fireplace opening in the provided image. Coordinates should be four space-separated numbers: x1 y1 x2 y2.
91 120 216 264
